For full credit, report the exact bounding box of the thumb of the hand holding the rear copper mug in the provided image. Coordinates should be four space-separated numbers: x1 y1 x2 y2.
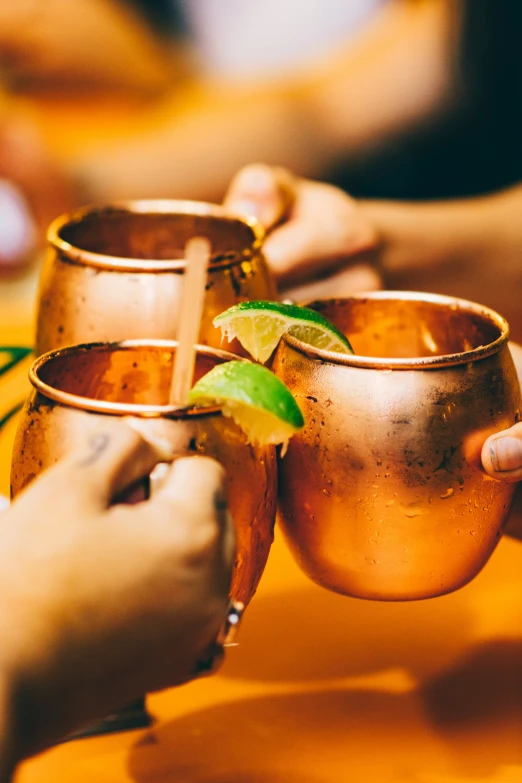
224 163 295 229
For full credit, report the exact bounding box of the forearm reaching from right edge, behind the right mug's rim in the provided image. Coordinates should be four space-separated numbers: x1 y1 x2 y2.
362 187 522 341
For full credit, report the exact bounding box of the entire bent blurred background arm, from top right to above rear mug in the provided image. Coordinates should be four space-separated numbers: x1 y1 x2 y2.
73 0 459 205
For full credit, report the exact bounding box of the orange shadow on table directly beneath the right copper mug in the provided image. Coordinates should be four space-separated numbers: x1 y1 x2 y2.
218 584 471 682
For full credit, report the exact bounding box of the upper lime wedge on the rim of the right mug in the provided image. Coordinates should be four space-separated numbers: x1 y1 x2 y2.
213 302 353 363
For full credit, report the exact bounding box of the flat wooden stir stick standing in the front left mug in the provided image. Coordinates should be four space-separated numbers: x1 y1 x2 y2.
169 237 211 405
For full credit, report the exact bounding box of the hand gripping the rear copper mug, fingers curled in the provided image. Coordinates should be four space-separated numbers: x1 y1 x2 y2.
224 164 381 302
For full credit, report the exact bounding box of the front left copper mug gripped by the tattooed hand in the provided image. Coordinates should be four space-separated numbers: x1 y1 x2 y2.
11 341 276 603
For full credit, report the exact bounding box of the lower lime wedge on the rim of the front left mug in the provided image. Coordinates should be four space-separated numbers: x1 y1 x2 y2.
189 361 304 445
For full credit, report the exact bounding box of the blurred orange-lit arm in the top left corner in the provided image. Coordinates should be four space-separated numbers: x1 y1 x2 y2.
0 0 176 93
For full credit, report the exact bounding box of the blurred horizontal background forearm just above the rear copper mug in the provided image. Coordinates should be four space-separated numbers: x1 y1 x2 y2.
72 85 318 201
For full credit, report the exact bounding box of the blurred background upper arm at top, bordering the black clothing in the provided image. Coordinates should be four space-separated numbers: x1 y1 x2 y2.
304 0 461 159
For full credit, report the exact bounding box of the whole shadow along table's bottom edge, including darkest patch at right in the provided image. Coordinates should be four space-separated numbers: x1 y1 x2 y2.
128 641 522 783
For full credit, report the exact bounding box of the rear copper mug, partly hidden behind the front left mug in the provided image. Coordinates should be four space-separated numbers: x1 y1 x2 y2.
36 200 276 356
